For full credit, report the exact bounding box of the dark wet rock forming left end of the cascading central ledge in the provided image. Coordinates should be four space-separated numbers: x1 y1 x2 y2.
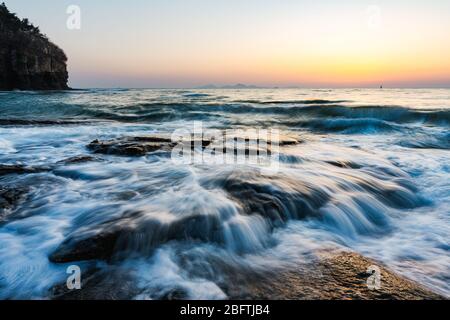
49 212 223 263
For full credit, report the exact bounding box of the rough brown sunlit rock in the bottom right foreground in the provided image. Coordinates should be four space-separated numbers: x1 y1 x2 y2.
228 252 444 300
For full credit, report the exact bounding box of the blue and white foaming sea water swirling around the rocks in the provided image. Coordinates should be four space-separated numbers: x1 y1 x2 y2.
0 89 450 299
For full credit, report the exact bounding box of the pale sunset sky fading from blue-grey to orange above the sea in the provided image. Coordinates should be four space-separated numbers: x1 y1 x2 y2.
4 0 450 88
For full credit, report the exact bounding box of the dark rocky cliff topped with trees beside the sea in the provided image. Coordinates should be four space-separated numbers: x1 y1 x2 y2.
0 4 69 90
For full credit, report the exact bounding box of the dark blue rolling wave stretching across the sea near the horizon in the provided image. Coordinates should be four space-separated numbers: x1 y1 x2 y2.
0 92 450 131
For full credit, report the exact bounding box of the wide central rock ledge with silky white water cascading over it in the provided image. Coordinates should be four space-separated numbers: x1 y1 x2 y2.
44 157 427 263
